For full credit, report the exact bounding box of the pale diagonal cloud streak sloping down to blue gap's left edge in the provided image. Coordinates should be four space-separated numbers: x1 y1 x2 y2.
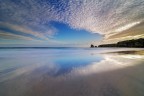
0 22 57 40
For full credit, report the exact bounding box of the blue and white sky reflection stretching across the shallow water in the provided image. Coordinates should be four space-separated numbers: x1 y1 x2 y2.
0 49 144 82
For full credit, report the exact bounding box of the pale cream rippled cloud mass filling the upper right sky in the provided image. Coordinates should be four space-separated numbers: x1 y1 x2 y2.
62 0 144 35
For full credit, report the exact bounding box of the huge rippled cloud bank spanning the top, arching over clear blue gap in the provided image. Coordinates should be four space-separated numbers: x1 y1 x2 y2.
0 0 144 45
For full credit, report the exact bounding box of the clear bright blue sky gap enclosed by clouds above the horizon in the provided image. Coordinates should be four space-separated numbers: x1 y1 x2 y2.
52 22 102 44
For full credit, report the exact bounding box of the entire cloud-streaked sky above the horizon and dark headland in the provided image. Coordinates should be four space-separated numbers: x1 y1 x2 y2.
0 0 144 47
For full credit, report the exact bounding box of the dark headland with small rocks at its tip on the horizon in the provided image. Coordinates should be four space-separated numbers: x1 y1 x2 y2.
90 38 144 48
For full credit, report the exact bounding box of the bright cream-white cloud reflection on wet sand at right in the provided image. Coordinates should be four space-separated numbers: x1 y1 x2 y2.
71 54 144 75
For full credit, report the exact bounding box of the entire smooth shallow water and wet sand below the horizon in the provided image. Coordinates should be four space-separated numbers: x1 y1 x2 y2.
0 48 144 96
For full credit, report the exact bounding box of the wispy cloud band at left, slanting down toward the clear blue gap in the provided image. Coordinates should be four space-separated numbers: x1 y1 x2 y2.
0 22 56 40
